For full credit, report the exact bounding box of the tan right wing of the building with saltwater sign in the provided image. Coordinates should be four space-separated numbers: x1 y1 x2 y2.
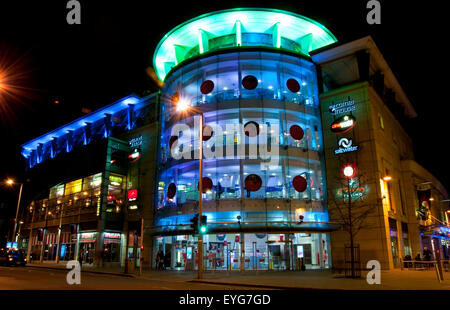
312 37 450 269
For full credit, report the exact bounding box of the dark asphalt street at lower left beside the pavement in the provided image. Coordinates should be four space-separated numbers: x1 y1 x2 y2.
0 267 264 290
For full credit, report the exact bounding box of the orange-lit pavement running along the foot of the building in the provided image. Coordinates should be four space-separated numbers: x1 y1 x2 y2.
22 262 450 290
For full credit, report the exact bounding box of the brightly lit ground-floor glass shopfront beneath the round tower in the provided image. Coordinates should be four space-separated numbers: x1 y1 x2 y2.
153 233 331 271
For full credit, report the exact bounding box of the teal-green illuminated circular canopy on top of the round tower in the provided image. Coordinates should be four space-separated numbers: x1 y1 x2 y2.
153 8 337 80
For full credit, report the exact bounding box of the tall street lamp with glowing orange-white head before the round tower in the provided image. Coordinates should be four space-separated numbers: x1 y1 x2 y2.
176 98 203 279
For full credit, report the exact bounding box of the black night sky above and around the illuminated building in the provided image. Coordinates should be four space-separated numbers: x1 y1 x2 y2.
0 0 450 218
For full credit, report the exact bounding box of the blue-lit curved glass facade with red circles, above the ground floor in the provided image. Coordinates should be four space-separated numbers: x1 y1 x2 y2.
155 49 328 230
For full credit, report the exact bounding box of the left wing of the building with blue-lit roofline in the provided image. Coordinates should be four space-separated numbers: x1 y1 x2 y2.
19 93 159 266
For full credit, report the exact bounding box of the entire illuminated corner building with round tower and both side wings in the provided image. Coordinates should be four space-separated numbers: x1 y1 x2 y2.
19 8 450 270
